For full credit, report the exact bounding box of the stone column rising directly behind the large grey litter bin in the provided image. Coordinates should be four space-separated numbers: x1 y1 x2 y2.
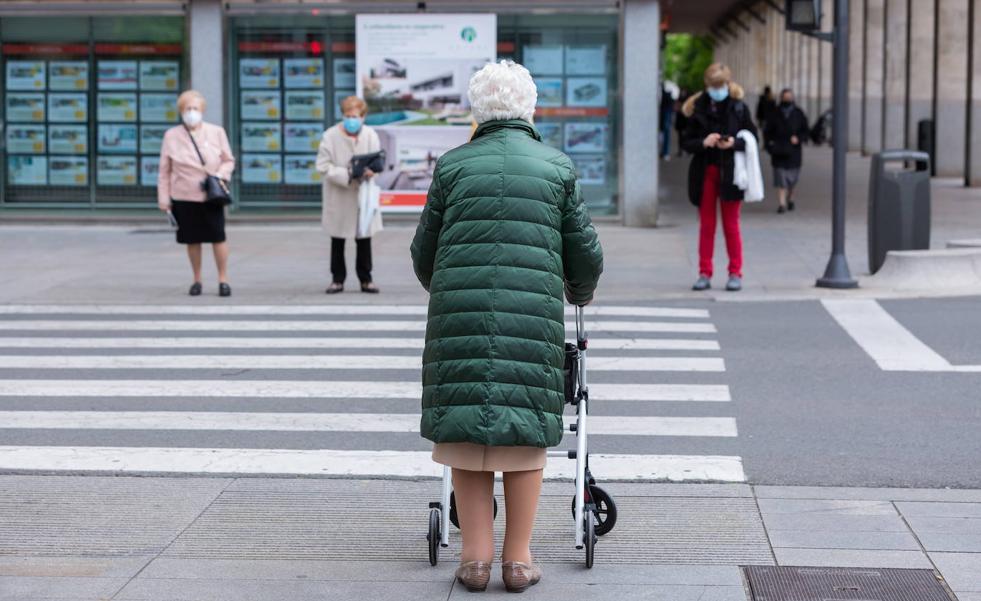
882 0 909 148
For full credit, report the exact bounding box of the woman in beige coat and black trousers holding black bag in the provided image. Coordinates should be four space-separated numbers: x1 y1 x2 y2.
317 96 381 294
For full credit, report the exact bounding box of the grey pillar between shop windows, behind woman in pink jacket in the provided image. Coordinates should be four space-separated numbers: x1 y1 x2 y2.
187 0 227 126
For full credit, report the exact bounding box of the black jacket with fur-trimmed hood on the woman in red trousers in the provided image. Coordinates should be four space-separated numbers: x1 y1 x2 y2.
681 83 759 207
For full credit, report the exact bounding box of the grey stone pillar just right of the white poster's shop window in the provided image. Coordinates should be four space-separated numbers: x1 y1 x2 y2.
620 0 661 227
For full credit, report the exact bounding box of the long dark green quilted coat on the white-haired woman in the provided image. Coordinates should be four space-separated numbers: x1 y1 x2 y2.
412 120 603 447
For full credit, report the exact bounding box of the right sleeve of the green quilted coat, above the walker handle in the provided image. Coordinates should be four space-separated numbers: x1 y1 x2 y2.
562 175 603 305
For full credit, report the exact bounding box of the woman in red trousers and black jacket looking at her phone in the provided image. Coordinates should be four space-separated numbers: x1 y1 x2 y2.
682 63 757 292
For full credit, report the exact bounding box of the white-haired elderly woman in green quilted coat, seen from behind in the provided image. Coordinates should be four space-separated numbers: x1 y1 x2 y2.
411 61 603 592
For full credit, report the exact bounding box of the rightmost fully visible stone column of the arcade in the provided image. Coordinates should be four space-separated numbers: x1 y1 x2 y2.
935 0 968 177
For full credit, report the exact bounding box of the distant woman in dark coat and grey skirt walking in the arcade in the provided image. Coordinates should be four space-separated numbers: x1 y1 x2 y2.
763 88 810 213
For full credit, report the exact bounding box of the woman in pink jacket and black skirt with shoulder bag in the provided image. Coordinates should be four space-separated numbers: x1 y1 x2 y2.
157 90 235 296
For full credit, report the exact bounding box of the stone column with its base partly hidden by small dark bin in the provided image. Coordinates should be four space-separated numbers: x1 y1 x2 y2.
906 0 935 148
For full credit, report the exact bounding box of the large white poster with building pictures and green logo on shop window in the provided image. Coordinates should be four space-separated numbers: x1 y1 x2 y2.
355 14 497 212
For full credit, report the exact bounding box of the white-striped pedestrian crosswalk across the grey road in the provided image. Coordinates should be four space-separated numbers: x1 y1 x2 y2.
0 305 745 481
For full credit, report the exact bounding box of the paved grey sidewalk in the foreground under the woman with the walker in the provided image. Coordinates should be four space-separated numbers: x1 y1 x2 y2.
0 475 981 601
